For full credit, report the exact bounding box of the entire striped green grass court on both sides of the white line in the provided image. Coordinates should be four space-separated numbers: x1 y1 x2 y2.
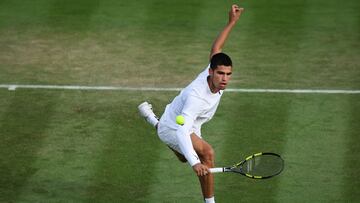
0 0 360 202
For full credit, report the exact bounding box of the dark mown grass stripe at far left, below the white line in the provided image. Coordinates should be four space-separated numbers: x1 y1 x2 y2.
0 91 56 202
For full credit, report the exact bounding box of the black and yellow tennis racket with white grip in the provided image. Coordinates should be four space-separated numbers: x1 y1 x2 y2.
210 152 284 179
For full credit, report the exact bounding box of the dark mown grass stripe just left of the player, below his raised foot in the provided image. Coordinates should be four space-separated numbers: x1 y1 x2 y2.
83 93 163 202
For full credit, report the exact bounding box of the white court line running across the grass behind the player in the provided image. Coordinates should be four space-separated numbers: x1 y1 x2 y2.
0 84 360 94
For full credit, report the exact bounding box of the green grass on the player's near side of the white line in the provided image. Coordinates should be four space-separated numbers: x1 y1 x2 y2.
0 90 360 202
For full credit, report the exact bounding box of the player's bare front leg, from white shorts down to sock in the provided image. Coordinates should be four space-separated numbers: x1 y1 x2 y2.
191 133 215 199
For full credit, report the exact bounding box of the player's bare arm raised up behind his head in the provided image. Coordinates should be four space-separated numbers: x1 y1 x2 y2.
210 5 244 59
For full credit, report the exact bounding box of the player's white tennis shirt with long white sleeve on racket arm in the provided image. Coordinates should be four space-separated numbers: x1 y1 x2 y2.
162 65 223 166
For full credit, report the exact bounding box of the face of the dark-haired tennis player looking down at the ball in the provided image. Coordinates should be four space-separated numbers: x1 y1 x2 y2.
209 65 232 93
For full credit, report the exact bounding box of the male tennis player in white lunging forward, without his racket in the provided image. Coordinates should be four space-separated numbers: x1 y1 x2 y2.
138 5 244 203
